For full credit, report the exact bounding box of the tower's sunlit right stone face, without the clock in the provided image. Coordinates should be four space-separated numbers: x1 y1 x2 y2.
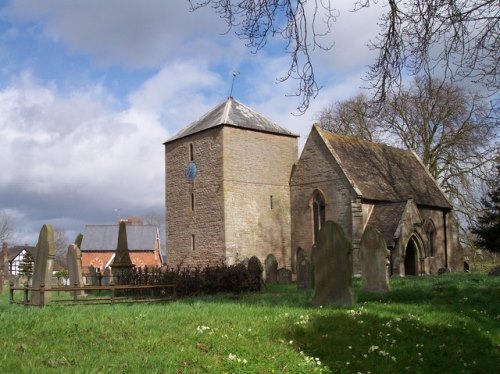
223 127 297 268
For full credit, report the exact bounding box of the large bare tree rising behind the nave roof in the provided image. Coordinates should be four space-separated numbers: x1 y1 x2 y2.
319 77 499 225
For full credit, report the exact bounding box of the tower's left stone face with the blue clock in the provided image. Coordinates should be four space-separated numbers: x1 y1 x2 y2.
165 127 225 266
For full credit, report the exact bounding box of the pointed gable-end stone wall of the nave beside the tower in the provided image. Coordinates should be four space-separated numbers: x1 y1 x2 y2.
290 129 356 268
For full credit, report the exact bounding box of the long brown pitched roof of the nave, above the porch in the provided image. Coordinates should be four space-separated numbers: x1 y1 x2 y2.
314 125 451 209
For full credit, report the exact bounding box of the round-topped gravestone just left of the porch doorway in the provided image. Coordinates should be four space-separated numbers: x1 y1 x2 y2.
360 225 390 292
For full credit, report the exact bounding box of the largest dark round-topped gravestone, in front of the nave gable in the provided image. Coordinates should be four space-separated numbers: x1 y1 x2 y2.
313 221 354 306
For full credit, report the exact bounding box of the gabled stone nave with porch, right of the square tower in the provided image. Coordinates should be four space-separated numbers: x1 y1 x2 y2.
290 125 463 275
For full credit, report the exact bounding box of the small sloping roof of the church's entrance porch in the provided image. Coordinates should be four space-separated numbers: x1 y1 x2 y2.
367 202 406 247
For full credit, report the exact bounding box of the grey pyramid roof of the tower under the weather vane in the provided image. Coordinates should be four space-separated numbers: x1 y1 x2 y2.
165 97 298 143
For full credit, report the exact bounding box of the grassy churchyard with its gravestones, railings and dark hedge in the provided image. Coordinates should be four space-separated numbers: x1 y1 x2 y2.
0 221 500 373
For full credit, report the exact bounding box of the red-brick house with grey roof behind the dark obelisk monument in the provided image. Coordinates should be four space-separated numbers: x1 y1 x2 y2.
81 225 163 271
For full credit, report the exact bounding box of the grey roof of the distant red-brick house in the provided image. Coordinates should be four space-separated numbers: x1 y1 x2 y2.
81 225 158 252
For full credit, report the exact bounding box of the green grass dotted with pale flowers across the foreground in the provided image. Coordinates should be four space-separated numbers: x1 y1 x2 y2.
0 273 500 374
